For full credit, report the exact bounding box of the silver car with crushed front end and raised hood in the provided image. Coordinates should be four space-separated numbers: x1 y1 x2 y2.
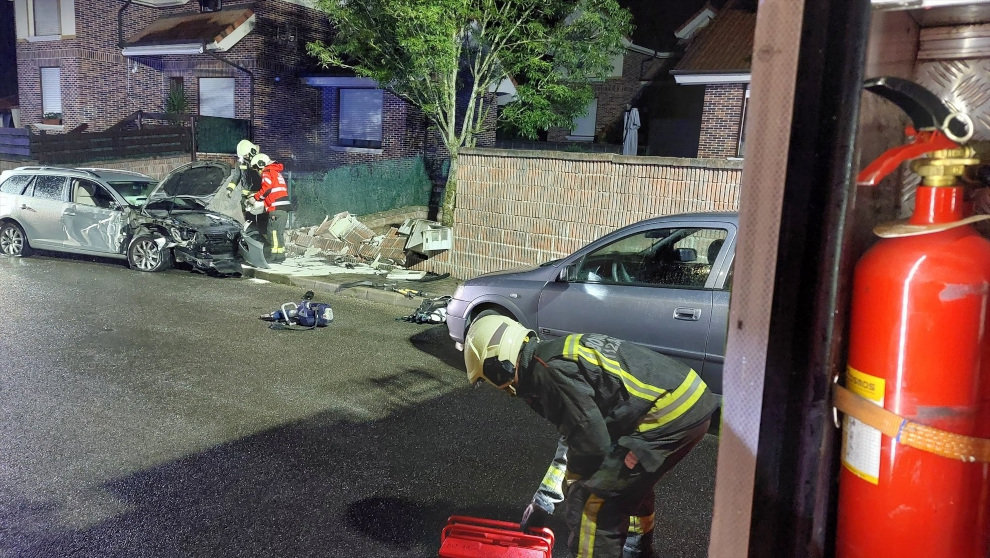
0 161 267 276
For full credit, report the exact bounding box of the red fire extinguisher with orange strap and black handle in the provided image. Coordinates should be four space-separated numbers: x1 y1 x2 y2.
835 77 990 558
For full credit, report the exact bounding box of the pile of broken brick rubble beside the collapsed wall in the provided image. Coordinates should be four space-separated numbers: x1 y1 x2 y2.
286 211 451 268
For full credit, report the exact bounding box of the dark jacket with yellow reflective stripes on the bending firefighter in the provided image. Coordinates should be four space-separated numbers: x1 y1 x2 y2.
517 334 719 476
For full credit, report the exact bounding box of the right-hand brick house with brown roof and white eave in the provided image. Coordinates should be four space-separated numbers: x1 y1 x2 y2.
670 1 756 158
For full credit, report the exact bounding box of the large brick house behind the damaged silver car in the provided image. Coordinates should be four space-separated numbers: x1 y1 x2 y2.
13 0 435 170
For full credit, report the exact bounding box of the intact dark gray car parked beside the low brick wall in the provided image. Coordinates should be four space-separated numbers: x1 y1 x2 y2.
447 213 738 394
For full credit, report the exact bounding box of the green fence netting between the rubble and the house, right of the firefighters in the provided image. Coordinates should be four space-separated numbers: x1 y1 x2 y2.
286 157 433 227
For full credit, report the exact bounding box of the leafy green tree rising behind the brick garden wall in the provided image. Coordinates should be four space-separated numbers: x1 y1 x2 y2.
307 0 630 226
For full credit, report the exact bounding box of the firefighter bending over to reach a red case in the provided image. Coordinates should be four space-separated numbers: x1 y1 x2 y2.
464 316 719 558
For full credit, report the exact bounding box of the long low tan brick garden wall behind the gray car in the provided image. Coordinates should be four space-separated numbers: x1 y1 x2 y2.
417 149 742 279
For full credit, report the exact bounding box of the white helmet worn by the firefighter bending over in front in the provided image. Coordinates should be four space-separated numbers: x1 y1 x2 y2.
464 315 536 395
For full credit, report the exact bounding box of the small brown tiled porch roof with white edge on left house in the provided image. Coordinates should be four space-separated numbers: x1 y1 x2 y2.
124 8 255 56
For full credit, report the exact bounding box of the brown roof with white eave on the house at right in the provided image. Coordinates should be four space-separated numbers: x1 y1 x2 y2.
670 9 756 83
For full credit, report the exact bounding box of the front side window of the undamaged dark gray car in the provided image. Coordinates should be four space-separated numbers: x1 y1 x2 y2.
572 227 728 289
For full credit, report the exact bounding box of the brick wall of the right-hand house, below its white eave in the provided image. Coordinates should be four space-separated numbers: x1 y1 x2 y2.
698 83 746 158
